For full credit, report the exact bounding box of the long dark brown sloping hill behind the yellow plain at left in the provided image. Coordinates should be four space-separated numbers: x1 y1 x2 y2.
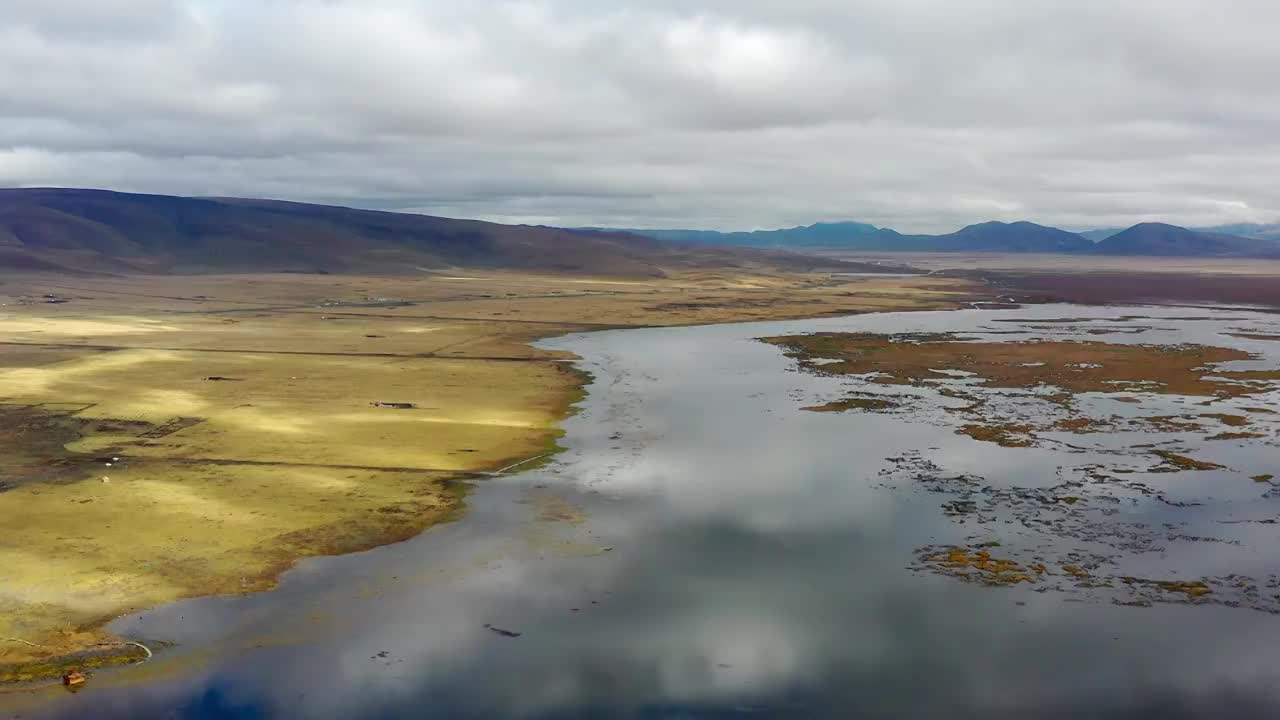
0 188 873 277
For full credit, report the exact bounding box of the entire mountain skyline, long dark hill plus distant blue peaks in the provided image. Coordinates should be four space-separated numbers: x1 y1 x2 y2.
0 188 1280 271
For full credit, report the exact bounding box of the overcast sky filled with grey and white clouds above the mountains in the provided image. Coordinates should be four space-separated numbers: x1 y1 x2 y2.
0 0 1280 232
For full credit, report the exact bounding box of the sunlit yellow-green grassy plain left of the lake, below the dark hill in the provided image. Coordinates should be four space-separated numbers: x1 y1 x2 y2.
0 266 980 680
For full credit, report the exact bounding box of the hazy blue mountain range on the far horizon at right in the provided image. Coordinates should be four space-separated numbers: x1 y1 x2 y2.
594 222 1280 258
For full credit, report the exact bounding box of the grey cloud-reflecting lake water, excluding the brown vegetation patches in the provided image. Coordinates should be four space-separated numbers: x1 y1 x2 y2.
0 299 1280 719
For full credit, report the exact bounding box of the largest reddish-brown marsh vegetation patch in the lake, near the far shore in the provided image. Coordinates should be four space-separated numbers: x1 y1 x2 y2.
762 330 1280 461
